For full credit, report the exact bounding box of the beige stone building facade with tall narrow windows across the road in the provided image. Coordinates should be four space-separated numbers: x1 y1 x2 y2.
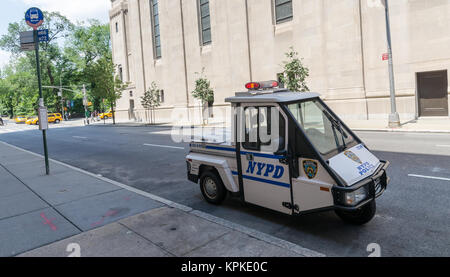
110 0 450 122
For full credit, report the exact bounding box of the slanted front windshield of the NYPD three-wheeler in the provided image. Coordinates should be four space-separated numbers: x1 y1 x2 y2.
287 100 354 155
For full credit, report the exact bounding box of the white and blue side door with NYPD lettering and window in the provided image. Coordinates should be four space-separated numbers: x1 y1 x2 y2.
238 105 292 214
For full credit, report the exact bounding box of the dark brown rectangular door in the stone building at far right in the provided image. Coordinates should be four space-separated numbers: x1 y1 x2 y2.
417 70 448 116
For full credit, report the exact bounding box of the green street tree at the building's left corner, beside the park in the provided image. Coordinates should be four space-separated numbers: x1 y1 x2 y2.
91 55 129 124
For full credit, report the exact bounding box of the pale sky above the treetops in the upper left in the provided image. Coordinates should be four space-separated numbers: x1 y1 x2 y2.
0 0 111 68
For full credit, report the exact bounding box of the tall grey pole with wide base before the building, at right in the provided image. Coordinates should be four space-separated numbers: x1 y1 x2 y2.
381 0 400 128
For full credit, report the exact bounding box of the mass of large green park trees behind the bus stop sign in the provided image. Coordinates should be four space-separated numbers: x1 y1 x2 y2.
0 12 114 119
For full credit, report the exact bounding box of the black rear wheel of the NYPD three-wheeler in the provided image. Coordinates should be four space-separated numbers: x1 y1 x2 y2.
200 171 227 205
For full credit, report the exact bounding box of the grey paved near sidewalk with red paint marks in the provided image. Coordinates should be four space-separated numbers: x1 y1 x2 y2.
0 142 323 257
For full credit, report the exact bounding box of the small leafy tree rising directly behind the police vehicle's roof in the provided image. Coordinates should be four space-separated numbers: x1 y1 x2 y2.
281 47 309 92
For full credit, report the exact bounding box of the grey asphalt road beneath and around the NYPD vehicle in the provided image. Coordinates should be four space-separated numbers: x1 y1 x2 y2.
0 125 450 256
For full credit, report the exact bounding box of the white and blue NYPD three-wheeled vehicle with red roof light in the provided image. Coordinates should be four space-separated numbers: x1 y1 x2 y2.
186 81 389 224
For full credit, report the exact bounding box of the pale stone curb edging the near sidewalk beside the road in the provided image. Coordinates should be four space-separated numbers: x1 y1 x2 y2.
0 141 326 257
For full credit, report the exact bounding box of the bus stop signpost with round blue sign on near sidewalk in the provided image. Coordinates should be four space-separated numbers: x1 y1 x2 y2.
24 7 50 175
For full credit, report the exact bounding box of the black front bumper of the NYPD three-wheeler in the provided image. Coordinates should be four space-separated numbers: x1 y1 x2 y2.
332 161 390 211
